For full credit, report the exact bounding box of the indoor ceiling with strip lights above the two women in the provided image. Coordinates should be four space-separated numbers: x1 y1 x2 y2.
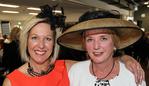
0 0 147 21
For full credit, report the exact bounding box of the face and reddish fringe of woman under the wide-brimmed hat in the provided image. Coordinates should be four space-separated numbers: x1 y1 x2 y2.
85 29 114 63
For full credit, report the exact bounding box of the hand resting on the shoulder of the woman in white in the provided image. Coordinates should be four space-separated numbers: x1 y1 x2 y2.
121 55 145 84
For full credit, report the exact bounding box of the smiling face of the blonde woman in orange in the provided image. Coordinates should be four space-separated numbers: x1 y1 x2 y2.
28 23 54 64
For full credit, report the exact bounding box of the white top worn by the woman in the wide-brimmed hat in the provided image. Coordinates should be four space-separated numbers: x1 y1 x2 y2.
69 60 146 86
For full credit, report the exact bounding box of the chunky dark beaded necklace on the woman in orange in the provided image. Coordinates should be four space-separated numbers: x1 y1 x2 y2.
27 63 54 77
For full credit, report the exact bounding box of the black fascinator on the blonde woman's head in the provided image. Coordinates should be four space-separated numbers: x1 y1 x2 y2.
36 4 66 28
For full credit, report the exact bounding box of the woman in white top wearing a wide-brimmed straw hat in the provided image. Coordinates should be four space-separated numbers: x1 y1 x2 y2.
58 11 146 86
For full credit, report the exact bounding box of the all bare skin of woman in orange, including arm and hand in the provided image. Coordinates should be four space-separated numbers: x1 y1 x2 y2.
3 23 144 86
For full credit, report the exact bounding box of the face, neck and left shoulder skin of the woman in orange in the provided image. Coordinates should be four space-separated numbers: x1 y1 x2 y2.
3 23 54 86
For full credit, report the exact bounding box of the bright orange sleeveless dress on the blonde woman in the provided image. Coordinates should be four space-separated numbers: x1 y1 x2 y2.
7 60 69 86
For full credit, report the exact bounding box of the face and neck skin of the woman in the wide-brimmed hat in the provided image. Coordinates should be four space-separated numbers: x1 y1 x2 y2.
85 29 119 79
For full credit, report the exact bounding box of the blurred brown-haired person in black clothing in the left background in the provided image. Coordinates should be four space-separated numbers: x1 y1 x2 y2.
2 27 22 73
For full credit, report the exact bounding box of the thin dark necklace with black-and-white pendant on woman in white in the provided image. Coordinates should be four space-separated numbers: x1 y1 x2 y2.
91 61 115 86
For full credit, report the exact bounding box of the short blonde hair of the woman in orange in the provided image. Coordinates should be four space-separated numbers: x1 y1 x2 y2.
20 17 56 61
